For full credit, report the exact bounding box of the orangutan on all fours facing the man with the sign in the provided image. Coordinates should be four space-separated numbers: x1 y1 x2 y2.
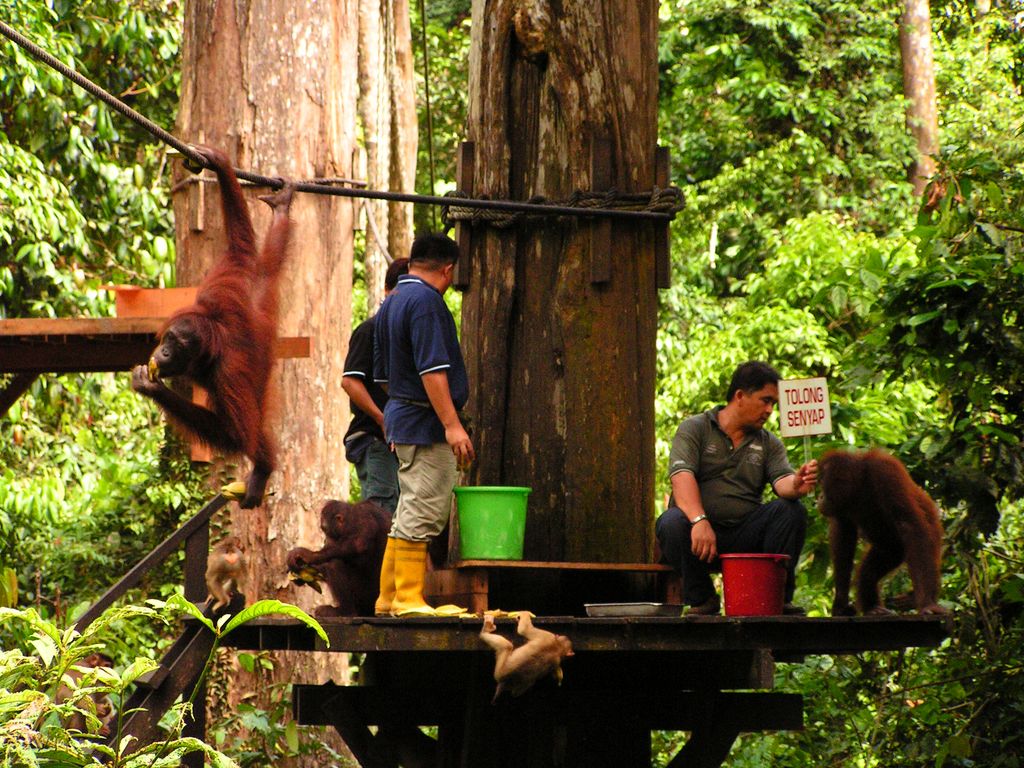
818 450 946 615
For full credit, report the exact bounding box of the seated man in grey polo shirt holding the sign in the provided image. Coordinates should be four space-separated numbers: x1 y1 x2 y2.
654 360 818 614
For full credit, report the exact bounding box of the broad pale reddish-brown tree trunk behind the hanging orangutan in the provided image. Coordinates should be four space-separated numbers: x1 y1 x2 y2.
174 0 357 757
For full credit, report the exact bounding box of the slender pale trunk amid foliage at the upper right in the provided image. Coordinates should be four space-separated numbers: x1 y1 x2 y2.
899 0 939 195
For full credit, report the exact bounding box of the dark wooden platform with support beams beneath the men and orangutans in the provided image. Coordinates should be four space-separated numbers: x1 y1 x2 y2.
225 615 948 768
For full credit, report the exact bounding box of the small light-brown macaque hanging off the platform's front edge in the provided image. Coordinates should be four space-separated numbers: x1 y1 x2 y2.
480 611 572 703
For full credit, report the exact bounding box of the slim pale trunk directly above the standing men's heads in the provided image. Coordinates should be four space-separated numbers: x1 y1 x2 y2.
358 0 417 314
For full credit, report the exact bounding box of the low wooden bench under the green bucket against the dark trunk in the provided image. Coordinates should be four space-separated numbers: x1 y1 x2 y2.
424 560 682 615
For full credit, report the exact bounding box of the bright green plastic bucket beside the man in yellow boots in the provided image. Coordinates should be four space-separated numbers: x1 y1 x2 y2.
455 485 530 560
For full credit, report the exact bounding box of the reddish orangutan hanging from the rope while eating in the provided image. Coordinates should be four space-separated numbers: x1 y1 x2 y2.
132 146 294 509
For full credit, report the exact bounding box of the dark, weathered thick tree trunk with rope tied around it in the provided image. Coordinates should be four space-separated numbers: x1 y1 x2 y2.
462 0 657 562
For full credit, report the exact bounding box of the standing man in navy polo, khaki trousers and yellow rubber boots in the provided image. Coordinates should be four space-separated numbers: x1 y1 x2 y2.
374 234 475 615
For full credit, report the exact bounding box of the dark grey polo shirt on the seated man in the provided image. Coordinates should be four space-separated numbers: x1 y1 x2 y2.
669 406 793 525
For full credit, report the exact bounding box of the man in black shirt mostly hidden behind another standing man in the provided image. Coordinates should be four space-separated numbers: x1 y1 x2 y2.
341 259 409 514
